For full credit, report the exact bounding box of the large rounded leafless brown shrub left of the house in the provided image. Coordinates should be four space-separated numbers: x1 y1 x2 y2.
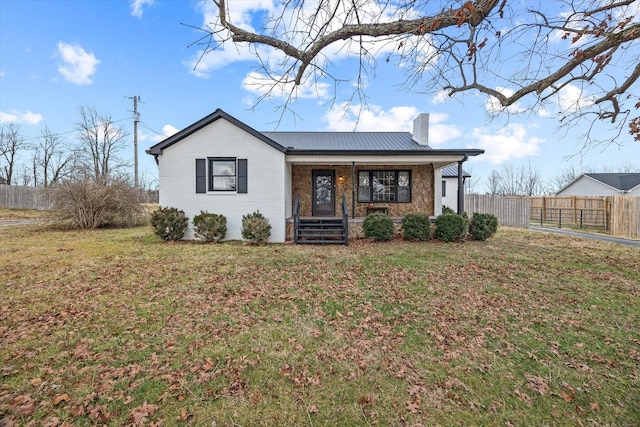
53 180 143 229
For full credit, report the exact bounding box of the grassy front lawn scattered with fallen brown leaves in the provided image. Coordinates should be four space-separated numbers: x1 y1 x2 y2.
0 222 640 426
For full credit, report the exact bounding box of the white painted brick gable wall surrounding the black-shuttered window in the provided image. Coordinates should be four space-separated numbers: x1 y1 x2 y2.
158 118 286 242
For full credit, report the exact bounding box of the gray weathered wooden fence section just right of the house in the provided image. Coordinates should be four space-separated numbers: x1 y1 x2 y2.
464 194 530 228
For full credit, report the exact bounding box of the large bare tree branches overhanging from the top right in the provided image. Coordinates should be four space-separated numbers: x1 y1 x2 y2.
206 0 640 148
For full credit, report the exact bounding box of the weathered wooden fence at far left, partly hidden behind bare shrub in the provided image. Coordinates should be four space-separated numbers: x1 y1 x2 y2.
0 184 158 210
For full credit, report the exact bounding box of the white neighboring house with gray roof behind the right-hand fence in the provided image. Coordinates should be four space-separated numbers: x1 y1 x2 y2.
556 173 640 197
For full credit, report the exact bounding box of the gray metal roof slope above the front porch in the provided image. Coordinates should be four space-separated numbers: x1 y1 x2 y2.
261 132 433 153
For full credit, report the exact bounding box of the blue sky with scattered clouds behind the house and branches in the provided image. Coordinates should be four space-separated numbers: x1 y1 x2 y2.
0 0 640 192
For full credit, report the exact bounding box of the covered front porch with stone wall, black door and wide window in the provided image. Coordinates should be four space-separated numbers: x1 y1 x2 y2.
287 155 462 243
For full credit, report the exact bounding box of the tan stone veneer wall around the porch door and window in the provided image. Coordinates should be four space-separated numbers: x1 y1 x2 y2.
292 164 434 217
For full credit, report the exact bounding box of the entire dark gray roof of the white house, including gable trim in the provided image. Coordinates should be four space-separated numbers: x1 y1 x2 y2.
147 109 484 156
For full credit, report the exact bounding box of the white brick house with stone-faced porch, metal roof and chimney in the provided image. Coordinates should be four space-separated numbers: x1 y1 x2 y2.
147 109 484 242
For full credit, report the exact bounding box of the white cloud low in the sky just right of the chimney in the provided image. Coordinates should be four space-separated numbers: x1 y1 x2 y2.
472 123 544 165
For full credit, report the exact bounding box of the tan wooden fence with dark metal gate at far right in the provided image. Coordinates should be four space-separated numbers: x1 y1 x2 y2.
529 196 640 237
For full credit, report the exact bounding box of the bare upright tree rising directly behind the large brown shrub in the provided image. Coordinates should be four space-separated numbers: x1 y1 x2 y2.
76 106 129 184
